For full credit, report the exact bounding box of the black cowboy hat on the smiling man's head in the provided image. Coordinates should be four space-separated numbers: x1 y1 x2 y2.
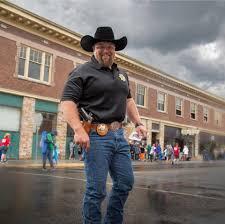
80 26 127 52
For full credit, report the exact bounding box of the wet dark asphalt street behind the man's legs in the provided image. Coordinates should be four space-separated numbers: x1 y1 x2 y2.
0 162 225 224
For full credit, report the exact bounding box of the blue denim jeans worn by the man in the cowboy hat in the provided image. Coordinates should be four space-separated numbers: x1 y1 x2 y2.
83 129 134 224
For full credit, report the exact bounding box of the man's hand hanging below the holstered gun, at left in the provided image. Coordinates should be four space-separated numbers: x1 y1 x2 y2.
74 126 90 151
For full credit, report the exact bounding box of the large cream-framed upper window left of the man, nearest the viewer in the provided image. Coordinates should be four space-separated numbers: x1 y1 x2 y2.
18 45 52 83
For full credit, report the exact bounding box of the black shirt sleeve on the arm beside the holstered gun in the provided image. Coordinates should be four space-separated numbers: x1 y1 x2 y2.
61 70 83 103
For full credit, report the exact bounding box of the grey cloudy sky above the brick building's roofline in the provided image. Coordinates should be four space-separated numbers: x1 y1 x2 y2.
11 0 225 98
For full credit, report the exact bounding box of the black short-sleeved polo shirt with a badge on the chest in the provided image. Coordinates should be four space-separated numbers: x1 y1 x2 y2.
61 56 131 123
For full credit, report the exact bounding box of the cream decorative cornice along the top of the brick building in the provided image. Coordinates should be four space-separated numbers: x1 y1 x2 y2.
0 0 225 105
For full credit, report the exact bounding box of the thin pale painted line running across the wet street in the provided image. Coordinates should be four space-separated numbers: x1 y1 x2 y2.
10 171 225 201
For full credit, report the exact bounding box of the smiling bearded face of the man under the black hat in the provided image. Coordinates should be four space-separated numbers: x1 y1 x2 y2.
93 42 115 68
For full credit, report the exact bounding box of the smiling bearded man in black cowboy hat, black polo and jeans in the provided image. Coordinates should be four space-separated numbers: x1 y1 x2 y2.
61 27 146 224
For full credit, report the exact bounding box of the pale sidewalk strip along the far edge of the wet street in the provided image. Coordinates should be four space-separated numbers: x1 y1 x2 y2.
0 160 225 169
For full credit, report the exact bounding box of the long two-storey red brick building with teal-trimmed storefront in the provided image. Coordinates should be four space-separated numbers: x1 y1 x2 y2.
0 0 225 159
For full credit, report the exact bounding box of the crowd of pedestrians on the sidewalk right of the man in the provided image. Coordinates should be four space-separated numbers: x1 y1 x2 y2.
129 141 191 164
